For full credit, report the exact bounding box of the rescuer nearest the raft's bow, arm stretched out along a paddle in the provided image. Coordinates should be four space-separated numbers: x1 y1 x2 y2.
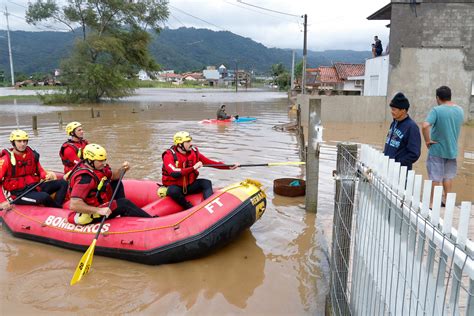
162 132 239 210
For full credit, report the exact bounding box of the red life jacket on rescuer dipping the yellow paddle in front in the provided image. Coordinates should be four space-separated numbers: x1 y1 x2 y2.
69 163 113 206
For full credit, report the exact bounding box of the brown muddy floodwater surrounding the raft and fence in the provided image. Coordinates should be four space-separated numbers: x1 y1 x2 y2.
0 89 474 315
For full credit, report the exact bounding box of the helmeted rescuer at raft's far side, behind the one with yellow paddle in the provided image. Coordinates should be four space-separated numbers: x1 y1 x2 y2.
59 122 89 174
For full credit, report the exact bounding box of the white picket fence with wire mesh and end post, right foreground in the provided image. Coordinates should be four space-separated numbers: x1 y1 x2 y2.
329 144 474 315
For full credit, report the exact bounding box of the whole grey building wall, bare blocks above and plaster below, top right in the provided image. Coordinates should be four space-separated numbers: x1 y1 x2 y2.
387 0 474 120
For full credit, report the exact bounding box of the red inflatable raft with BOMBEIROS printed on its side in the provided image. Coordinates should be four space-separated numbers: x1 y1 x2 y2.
0 179 266 265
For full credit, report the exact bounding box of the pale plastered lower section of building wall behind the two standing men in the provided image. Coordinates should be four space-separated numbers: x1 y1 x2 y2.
387 48 474 121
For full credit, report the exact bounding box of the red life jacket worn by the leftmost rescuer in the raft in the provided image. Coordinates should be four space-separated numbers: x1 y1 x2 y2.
0 146 40 191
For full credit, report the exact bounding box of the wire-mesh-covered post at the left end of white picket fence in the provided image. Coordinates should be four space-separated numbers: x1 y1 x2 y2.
330 143 357 315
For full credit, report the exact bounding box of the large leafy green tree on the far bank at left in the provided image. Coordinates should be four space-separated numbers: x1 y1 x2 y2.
26 0 169 102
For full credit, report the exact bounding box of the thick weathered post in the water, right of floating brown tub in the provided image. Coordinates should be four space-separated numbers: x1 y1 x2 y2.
303 99 322 213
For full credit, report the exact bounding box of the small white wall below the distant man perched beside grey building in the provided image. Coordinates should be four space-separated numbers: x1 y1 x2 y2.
364 55 389 96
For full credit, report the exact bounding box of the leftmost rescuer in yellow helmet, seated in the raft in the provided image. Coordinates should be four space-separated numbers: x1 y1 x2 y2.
0 129 67 209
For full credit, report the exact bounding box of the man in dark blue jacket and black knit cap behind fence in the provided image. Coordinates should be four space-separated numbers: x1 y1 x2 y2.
383 92 421 170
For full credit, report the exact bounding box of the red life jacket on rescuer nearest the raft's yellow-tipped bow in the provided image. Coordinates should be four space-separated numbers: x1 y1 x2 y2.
161 146 199 187
